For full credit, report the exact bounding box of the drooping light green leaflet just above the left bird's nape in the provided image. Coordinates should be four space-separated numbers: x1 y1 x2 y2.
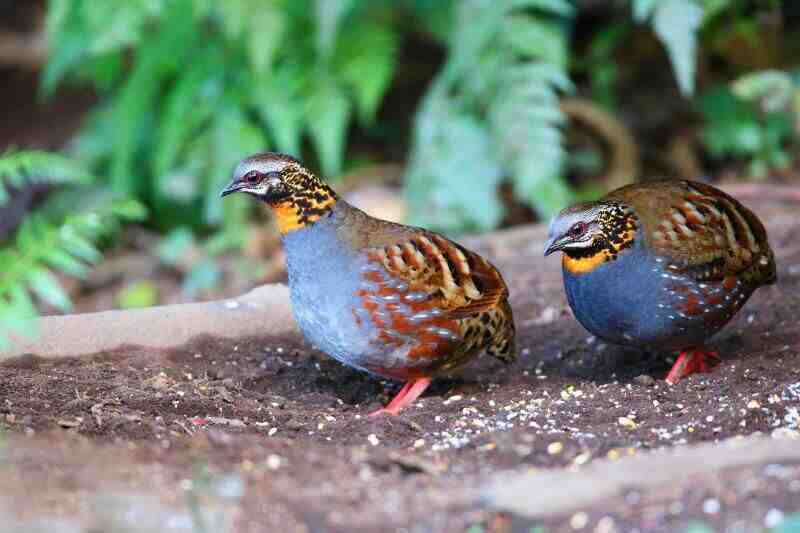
306 80 351 177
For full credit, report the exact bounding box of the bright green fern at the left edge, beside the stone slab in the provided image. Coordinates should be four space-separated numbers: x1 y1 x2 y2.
0 152 145 349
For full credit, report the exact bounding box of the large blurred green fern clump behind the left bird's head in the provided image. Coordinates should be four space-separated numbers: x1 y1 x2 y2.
42 0 398 244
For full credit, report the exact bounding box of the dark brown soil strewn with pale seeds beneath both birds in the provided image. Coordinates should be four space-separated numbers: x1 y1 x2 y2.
0 197 800 532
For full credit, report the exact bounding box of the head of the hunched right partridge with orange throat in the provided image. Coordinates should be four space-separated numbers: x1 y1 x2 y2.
544 201 637 273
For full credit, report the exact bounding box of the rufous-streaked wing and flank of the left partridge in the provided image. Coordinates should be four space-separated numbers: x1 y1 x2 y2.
354 232 514 369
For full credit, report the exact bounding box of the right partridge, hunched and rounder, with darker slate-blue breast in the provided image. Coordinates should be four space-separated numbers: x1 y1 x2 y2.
545 181 776 383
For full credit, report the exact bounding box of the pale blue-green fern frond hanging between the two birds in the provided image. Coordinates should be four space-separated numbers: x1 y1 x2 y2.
407 0 573 232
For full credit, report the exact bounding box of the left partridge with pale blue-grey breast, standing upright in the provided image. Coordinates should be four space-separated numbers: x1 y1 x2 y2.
221 153 516 415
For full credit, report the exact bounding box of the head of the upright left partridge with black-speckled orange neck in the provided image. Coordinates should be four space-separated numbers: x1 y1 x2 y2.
220 152 338 234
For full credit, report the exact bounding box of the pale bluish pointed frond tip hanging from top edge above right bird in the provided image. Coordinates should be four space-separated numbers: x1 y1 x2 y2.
653 0 703 96
